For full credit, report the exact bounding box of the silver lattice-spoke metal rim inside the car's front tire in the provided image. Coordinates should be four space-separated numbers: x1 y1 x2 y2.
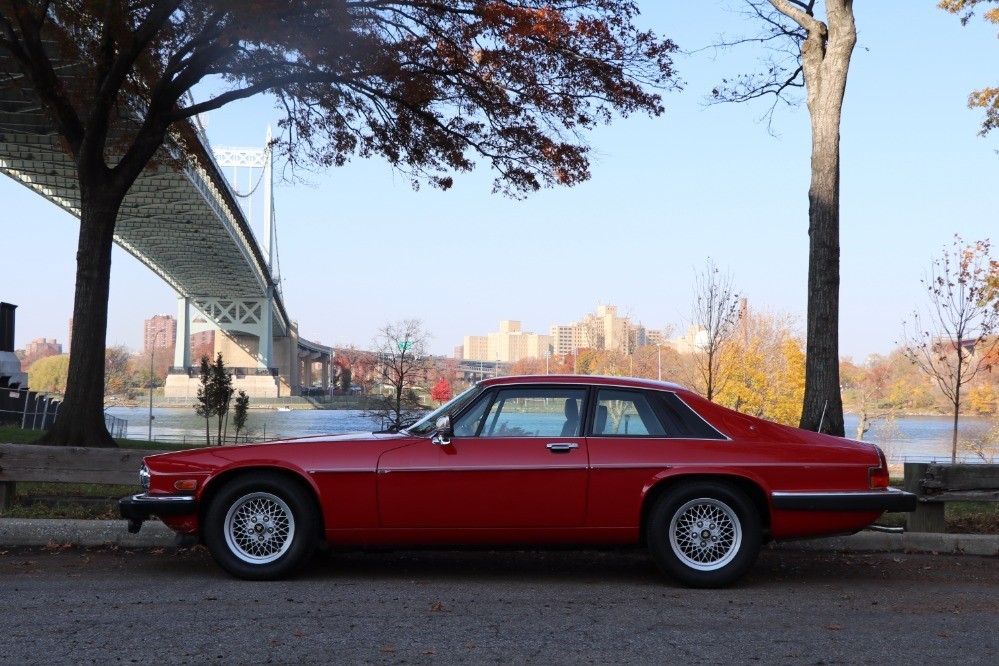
223 492 295 564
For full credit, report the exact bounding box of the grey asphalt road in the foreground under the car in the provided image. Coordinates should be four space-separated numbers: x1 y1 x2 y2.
0 548 999 665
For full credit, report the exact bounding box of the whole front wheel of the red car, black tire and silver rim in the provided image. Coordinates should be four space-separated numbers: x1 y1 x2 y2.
204 472 319 580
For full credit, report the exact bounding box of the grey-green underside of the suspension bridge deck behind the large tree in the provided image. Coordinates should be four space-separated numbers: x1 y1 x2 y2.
0 68 288 334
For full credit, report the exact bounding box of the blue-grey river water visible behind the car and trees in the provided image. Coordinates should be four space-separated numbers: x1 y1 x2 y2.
107 407 992 465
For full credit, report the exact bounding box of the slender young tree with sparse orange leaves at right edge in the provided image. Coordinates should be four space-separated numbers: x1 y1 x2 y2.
901 236 999 463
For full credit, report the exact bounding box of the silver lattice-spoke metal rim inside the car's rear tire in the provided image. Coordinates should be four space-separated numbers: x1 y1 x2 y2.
669 497 742 571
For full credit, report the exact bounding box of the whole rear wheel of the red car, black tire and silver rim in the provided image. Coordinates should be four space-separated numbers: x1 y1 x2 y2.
646 481 763 588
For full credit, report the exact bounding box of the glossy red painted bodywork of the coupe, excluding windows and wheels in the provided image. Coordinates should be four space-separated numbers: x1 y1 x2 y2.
135 376 908 546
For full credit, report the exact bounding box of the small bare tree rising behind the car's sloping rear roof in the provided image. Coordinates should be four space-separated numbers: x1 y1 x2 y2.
690 257 741 400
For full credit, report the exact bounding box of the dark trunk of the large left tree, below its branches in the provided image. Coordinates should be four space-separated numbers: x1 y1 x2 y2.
41 180 125 447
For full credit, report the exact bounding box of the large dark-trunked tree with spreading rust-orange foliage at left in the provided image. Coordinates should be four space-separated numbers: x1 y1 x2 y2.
0 0 675 446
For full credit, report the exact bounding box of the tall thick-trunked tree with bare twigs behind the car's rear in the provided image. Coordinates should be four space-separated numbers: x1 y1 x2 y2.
711 0 857 436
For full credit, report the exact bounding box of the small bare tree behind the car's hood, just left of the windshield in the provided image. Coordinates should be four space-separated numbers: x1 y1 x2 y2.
371 319 430 430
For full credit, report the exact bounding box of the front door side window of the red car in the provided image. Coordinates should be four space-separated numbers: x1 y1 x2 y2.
472 387 586 437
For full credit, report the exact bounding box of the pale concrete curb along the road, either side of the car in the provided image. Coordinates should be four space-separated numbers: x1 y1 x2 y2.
0 518 999 557
